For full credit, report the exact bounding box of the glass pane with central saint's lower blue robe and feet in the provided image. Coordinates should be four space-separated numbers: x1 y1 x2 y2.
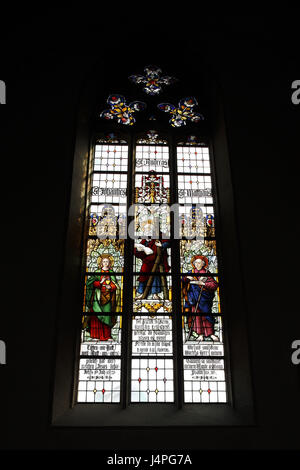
133 274 172 314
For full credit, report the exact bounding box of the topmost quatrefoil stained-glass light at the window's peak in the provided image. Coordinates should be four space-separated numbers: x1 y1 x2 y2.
128 65 176 96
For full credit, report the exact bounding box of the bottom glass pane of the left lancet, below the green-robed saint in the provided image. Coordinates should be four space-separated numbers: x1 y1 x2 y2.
77 358 121 403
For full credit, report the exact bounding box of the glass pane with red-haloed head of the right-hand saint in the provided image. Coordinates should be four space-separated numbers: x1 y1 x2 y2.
180 240 218 274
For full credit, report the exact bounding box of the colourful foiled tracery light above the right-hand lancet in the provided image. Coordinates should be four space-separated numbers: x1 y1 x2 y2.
157 96 204 127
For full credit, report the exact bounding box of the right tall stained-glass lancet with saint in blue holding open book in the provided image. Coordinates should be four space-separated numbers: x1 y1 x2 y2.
177 140 227 403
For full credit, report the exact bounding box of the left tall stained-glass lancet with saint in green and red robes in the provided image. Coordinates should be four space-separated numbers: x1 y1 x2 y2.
77 138 128 403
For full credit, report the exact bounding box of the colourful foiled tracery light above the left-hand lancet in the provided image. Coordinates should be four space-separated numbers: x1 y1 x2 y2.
100 95 146 126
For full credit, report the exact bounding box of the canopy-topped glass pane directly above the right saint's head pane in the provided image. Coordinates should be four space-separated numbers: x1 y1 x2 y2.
179 203 215 240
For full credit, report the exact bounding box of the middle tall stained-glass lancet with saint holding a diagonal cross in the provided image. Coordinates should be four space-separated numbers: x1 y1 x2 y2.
131 136 174 403
